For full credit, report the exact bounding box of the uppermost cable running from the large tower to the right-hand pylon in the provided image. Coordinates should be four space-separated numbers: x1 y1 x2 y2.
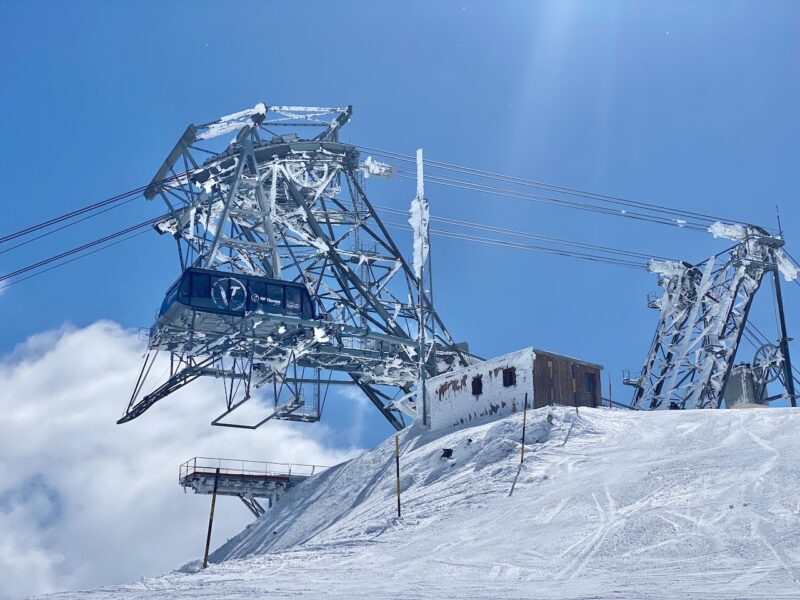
357 146 740 223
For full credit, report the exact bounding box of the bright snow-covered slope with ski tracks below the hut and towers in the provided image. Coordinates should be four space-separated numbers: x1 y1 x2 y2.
43 408 800 600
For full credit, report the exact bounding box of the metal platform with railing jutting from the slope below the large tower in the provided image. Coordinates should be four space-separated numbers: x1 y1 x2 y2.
178 456 328 517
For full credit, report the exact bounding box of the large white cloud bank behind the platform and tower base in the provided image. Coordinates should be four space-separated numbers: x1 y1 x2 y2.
0 322 354 600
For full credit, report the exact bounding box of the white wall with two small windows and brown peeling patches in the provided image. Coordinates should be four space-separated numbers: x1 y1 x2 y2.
427 348 536 429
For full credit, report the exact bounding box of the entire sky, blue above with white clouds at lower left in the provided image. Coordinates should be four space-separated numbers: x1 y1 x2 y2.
0 0 800 600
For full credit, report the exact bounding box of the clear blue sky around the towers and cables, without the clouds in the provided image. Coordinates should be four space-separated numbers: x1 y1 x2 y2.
0 0 800 445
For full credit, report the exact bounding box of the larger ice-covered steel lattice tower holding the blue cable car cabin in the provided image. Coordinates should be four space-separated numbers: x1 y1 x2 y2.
120 104 468 429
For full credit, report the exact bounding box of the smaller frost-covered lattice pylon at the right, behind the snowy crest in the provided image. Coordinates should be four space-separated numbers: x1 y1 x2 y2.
625 222 798 409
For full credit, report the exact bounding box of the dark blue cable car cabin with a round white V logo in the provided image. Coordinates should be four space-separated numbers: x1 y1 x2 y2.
156 267 316 342
